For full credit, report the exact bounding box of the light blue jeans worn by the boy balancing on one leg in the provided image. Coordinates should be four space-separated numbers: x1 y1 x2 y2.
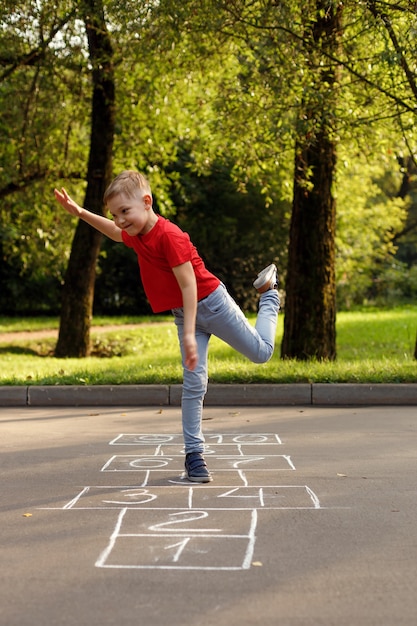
172 284 279 453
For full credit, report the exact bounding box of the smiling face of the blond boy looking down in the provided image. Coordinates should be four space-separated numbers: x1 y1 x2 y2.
107 192 156 237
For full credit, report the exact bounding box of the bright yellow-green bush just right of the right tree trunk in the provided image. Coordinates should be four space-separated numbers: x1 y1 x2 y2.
336 149 406 308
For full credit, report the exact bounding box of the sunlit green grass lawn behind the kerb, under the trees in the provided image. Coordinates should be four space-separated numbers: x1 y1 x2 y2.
0 306 417 385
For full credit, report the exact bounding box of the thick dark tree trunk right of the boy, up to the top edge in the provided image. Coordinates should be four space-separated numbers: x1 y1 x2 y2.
281 1 341 360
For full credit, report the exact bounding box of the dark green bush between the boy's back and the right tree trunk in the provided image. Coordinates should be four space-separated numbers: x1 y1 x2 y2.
167 153 288 311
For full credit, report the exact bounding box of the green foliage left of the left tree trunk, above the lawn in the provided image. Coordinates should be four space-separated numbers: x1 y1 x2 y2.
0 2 88 313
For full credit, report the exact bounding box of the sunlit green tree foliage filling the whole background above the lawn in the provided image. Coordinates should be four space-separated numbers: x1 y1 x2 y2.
0 0 417 356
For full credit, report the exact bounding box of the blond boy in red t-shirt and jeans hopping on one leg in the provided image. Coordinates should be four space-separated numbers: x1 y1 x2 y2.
54 170 279 483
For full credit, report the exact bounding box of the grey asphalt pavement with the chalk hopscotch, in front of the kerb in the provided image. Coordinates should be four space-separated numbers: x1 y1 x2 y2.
0 400 417 626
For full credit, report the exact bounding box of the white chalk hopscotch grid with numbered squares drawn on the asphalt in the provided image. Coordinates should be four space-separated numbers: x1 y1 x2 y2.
43 432 322 571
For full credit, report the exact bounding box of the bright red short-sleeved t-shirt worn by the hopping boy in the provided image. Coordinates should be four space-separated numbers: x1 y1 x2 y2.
122 215 220 313
